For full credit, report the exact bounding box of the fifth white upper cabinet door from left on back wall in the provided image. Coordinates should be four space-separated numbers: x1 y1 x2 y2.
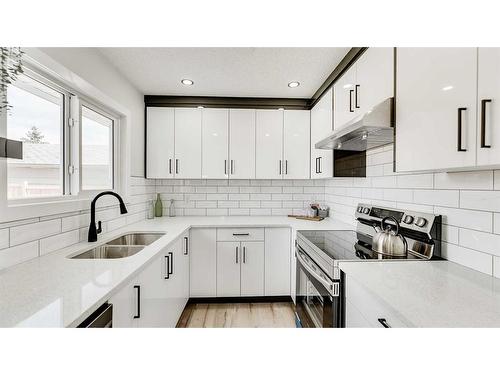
256 110 284 179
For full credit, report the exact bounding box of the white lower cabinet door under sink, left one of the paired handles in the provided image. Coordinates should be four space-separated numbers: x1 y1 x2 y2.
137 252 171 327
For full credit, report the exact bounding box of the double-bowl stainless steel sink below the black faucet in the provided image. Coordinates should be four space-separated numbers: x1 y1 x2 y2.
70 232 165 259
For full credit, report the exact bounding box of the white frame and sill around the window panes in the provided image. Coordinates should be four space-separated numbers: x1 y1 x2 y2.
0 55 130 223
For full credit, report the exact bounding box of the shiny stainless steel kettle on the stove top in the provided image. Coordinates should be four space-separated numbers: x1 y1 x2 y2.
372 216 408 258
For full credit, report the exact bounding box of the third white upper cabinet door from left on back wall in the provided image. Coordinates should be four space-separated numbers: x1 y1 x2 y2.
202 109 229 179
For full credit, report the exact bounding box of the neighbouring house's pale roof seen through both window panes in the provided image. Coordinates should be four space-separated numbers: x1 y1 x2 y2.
9 142 109 165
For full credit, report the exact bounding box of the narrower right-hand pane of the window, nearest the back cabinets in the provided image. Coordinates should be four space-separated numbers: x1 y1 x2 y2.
81 104 114 190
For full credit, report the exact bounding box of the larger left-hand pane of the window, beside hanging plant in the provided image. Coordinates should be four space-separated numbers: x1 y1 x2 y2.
7 75 65 199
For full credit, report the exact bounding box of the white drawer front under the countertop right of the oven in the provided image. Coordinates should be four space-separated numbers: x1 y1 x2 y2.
346 276 407 328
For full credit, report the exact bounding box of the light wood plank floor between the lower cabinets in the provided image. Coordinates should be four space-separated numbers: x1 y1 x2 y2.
177 302 295 328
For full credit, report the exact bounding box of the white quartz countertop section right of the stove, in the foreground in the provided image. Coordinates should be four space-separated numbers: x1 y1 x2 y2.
340 261 500 327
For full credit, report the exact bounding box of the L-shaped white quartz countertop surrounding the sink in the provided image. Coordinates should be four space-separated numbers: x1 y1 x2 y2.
0 216 353 327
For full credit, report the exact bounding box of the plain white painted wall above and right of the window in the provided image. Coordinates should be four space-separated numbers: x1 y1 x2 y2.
39 47 144 176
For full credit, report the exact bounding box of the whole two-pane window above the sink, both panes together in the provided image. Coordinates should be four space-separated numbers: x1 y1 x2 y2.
4 69 119 206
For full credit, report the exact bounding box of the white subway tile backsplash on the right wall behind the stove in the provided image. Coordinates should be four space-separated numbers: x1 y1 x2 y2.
325 145 500 277
